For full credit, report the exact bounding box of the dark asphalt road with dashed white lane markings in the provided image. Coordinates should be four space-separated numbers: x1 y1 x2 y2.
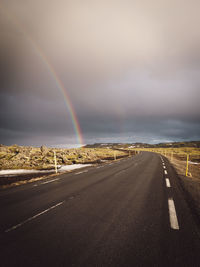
0 152 200 267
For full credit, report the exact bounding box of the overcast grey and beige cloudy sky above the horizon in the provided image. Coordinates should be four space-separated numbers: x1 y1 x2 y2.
0 0 200 146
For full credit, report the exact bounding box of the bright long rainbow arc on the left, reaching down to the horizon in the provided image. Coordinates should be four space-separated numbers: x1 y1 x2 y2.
0 6 84 146
